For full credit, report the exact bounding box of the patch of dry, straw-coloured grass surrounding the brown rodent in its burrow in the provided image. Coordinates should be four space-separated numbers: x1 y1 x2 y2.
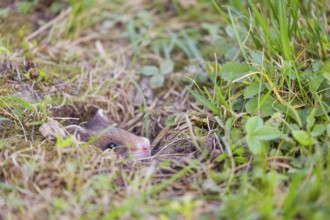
0 2 223 219
